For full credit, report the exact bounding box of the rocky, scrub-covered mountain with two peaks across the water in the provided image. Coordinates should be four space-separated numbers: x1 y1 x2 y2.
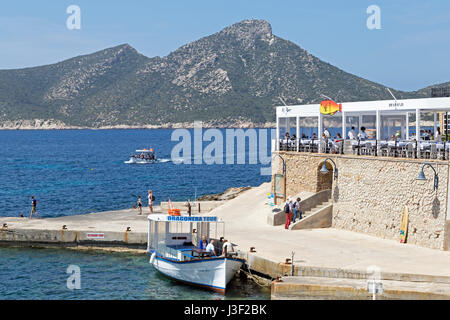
0 20 440 128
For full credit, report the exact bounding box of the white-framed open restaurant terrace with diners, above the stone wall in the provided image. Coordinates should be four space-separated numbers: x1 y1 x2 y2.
275 97 450 160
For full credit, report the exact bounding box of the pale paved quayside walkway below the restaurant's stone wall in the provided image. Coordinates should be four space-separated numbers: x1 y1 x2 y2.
210 183 450 277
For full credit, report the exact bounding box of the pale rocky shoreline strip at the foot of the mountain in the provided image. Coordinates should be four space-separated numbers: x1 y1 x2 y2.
0 119 276 130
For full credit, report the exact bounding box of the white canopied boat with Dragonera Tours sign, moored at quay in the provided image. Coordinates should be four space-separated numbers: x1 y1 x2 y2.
147 214 244 294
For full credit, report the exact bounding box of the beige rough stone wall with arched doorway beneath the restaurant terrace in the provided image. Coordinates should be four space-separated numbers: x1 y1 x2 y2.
272 152 450 250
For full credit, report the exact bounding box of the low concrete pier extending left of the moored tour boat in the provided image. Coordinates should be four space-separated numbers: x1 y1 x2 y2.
0 208 151 252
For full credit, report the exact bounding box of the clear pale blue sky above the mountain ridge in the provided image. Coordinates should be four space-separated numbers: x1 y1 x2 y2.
0 0 450 90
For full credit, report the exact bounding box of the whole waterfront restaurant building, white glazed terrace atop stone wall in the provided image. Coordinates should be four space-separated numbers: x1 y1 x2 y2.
272 97 450 250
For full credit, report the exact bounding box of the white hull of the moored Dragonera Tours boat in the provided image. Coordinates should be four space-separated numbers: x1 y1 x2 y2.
150 256 244 294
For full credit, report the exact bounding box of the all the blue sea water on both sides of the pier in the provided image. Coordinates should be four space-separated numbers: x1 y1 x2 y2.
0 129 271 300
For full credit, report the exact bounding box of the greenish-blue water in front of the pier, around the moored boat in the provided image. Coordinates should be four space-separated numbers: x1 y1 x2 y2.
0 248 270 300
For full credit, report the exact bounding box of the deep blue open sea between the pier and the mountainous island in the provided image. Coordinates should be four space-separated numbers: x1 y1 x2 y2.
0 130 270 217
